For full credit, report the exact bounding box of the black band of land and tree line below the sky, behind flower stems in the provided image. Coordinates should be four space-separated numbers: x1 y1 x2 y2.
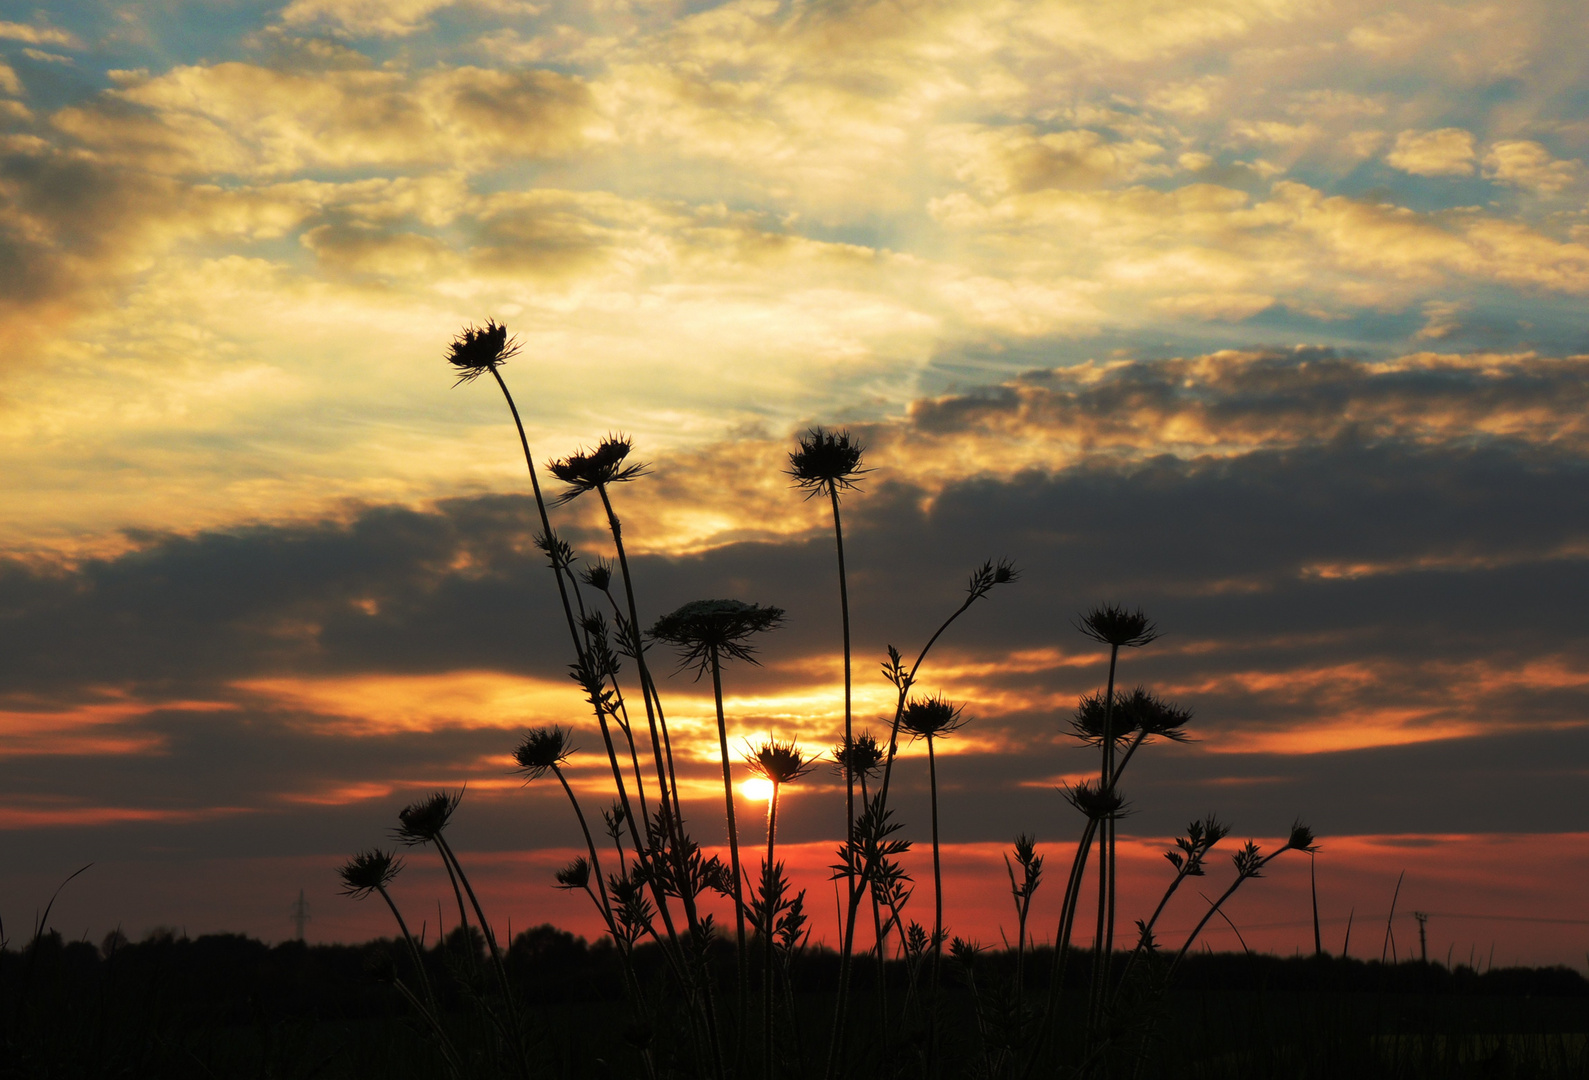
0 926 1589 1080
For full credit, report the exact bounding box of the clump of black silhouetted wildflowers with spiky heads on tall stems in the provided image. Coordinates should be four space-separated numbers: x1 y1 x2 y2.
343 322 1313 1080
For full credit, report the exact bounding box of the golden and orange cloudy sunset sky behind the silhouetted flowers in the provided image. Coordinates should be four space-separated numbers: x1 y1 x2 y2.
0 0 1589 967
